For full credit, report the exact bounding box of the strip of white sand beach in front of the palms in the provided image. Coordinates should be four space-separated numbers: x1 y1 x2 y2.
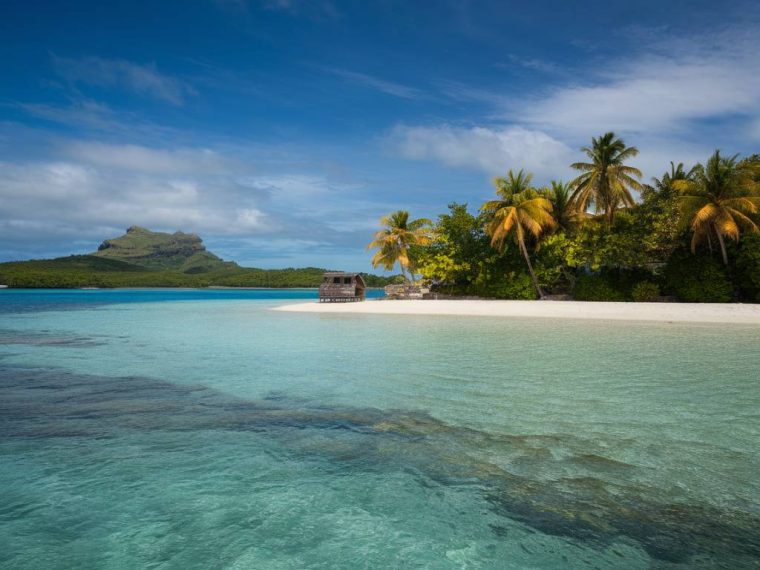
274 300 760 325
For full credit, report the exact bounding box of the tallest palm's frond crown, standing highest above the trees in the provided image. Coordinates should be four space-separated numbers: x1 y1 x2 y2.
570 133 642 226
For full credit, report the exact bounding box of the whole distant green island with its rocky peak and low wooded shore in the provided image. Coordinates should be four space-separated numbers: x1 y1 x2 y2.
0 226 398 288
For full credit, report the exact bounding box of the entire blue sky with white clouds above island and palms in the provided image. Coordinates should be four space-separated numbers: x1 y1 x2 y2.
0 0 760 271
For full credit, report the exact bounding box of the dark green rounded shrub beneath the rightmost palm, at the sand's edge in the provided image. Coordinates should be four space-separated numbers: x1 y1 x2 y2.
663 251 733 303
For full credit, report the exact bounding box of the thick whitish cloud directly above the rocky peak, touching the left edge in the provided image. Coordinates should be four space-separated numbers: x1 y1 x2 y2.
0 155 269 239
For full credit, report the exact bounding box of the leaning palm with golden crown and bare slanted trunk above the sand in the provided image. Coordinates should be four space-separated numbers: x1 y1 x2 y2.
480 170 555 298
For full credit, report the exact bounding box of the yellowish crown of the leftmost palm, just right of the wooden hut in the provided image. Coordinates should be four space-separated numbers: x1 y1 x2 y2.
367 210 432 281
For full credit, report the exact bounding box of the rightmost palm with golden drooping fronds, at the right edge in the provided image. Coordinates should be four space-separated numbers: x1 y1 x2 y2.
680 150 760 265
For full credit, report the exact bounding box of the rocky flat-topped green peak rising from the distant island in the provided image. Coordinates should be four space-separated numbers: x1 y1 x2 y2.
90 226 238 274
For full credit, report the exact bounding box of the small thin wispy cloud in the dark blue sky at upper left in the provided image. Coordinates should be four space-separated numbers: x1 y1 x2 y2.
53 56 193 105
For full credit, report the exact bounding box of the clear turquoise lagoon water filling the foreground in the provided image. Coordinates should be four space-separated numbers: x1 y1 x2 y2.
0 290 760 569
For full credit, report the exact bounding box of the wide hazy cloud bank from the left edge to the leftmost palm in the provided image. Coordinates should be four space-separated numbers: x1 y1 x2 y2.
0 140 390 266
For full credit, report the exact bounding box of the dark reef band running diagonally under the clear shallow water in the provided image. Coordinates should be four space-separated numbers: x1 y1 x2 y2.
0 367 760 568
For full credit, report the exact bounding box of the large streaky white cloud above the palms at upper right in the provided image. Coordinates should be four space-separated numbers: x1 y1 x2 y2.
390 24 760 179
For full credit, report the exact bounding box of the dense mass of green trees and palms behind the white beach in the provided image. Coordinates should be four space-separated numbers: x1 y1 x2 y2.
382 133 760 302
